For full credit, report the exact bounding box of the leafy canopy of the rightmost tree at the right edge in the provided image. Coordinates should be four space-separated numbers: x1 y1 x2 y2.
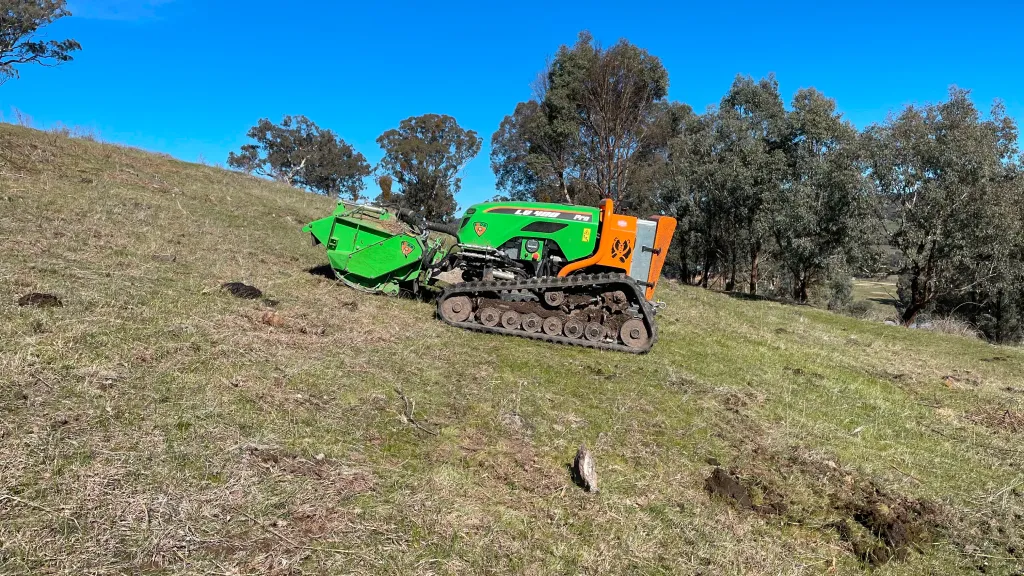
864 87 1021 324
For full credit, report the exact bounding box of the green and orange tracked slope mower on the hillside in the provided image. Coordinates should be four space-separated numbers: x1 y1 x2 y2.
303 200 676 353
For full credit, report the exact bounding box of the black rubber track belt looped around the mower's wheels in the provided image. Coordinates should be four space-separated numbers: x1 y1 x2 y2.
436 274 657 354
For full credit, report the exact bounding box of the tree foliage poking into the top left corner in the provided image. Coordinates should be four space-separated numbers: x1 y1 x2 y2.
0 0 82 84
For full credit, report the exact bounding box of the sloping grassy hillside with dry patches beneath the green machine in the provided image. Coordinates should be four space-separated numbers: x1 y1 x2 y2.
0 125 1024 575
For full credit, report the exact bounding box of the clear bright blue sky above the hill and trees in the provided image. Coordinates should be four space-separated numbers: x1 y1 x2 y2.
0 0 1024 206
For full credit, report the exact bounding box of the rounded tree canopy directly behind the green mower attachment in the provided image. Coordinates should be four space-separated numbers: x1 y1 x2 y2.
377 114 480 221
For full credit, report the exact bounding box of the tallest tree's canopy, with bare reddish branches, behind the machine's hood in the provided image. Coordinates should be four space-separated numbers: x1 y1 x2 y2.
490 32 669 204
